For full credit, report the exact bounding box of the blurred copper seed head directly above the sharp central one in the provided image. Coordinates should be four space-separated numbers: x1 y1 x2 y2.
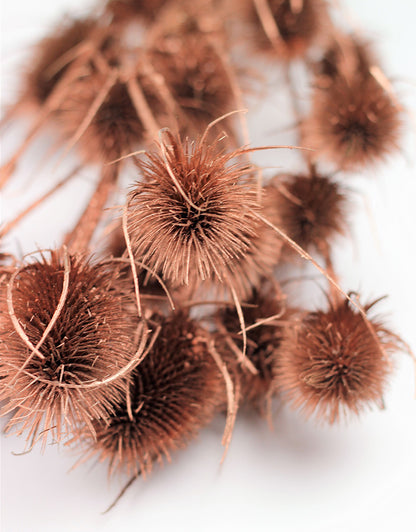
148 31 236 135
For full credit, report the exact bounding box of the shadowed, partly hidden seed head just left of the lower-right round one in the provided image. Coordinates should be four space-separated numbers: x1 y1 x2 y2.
216 281 291 414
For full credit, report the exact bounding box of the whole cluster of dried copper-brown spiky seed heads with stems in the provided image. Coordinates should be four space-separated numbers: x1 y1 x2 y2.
0 0 410 502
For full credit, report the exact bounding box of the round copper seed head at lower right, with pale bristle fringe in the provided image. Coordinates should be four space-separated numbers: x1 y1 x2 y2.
276 301 398 423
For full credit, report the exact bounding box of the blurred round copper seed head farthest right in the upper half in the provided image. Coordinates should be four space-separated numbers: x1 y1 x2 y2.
303 77 400 170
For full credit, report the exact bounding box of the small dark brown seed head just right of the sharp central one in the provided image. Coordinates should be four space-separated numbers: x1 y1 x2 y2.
266 173 346 257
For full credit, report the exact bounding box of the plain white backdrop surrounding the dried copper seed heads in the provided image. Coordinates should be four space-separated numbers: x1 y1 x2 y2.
0 0 416 532
